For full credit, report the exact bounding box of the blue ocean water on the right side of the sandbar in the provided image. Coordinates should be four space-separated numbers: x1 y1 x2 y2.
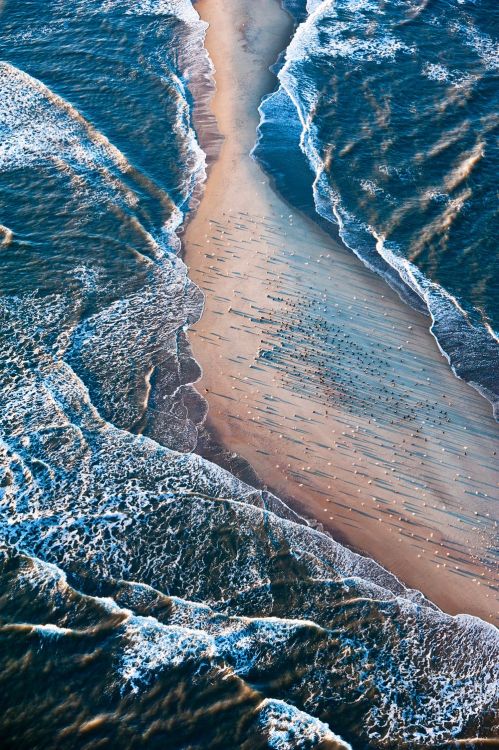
255 0 499 416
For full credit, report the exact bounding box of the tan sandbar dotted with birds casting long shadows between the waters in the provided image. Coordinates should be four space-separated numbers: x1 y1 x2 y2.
183 0 499 622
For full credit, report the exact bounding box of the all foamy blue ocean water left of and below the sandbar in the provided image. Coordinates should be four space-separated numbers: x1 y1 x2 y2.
0 0 499 750
